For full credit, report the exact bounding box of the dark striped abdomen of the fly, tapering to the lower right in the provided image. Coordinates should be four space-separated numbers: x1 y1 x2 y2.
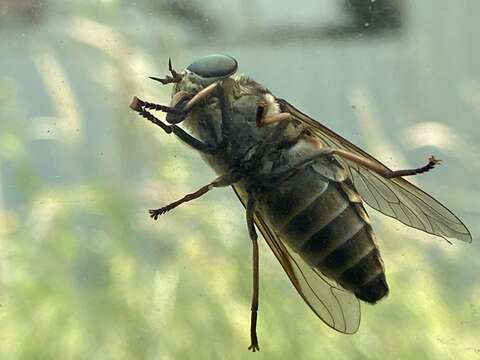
259 166 388 303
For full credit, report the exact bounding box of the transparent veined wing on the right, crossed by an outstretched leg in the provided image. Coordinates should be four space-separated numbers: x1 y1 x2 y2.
277 99 472 242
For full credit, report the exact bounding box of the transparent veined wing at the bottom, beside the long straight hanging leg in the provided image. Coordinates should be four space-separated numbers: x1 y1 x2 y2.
233 186 360 334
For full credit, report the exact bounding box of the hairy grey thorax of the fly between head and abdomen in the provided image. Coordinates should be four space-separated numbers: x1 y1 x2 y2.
178 74 313 179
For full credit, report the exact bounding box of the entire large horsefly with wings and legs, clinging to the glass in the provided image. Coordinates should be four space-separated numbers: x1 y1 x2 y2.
130 55 471 351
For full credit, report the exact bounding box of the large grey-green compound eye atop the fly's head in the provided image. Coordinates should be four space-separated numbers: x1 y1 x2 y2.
187 54 238 78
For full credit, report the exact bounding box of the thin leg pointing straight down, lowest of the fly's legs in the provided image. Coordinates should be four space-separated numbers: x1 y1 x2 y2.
247 193 260 352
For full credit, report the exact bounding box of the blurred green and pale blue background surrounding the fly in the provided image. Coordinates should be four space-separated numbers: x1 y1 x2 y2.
0 0 480 360
